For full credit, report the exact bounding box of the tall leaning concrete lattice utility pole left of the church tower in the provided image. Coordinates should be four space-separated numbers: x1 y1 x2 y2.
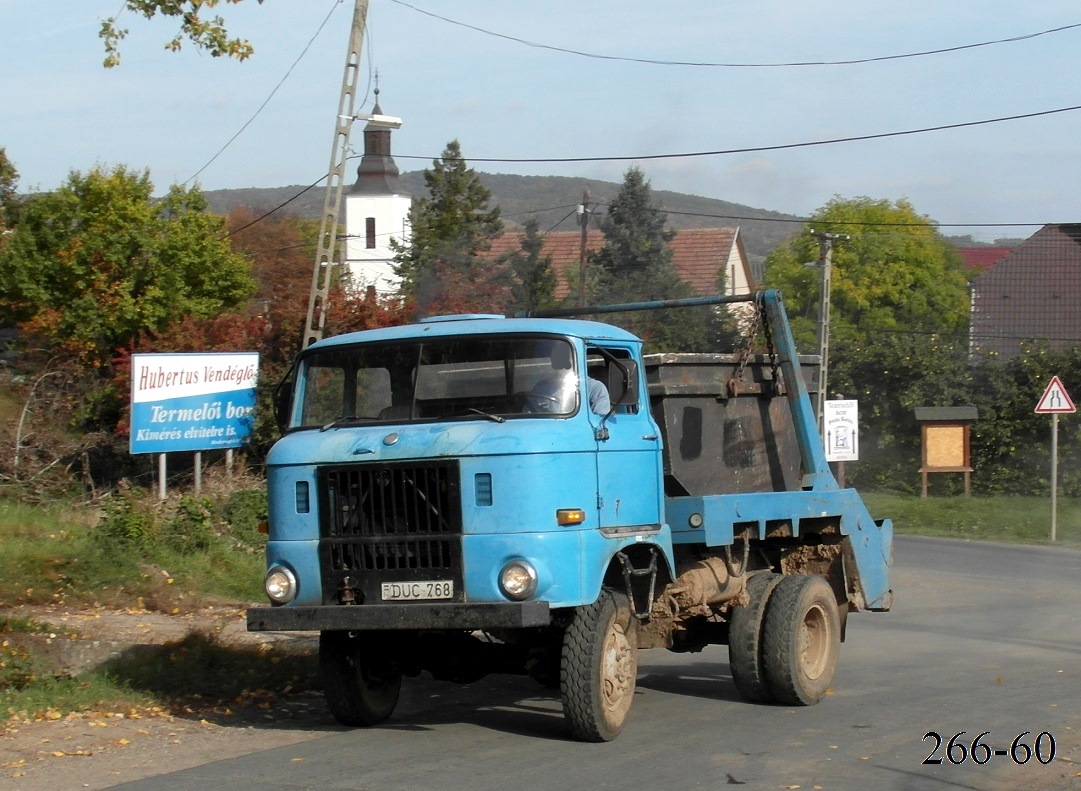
303 0 368 346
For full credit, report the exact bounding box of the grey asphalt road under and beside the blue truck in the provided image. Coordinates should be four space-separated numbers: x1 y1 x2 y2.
111 538 1081 791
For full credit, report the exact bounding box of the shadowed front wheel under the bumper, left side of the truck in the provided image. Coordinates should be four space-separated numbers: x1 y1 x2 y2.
319 631 402 727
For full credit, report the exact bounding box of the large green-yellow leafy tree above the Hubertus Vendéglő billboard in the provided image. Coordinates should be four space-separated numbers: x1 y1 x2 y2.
0 166 254 366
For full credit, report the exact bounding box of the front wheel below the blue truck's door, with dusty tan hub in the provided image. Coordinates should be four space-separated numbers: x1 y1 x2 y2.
559 589 638 741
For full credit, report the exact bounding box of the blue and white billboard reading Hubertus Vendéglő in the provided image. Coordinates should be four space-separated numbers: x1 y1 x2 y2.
130 352 259 454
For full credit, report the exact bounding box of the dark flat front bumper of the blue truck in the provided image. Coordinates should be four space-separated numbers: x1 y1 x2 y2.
248 602 551 632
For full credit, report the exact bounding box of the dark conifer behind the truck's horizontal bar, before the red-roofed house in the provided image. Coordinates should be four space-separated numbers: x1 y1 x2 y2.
588 167 723 351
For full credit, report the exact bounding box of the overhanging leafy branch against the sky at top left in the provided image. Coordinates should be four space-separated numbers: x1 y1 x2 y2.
98 0 263 68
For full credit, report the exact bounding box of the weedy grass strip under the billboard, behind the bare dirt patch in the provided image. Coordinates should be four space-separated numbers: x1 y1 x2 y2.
0 488 265 613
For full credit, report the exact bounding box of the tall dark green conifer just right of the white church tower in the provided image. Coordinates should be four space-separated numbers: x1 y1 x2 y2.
393 140 510 313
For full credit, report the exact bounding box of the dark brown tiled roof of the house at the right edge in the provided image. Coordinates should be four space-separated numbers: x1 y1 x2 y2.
969 224 1081 359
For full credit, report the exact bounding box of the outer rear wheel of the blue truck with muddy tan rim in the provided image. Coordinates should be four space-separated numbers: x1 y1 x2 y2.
762 574 841 706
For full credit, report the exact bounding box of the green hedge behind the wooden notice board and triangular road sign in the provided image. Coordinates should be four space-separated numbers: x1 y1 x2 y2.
829 333 1081 497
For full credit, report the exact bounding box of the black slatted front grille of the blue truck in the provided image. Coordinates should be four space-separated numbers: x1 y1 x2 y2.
319 461 462 603
